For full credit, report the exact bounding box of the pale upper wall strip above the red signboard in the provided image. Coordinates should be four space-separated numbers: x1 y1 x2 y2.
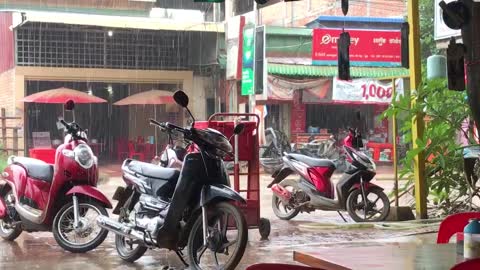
259 0 407 27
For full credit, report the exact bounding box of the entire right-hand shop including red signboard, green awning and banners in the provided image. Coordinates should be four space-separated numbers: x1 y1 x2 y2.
261 21 409 160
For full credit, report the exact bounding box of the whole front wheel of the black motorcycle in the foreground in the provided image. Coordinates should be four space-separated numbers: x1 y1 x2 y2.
187 202 248 270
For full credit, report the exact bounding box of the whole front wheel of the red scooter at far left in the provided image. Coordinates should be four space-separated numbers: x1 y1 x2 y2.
52 201 108 253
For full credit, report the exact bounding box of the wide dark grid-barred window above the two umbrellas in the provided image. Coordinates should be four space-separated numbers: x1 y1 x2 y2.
16 23 189 70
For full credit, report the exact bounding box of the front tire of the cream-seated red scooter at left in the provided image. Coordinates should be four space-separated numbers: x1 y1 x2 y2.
52 200 108 253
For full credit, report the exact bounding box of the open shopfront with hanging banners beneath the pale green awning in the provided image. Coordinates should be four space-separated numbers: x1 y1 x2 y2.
265 70 404 160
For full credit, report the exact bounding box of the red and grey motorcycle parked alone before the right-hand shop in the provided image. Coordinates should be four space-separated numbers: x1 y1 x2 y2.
268 145 390 222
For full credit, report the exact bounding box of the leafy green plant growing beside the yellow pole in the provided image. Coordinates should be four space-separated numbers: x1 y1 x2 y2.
383 80 470 215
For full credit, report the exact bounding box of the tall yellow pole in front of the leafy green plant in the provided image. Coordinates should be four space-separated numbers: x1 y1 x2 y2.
408 0 428 219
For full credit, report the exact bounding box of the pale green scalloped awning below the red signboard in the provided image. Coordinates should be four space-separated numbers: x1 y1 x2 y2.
267 63 409 79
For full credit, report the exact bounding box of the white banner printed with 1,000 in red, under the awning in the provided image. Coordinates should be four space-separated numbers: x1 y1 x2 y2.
332 78 404 104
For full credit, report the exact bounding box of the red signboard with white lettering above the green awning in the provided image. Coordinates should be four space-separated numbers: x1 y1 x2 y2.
312 28 402 67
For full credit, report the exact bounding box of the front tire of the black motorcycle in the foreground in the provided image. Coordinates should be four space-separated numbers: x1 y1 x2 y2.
187 202 248 270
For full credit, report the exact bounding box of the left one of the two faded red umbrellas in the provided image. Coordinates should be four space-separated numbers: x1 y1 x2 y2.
23 87 107 103
